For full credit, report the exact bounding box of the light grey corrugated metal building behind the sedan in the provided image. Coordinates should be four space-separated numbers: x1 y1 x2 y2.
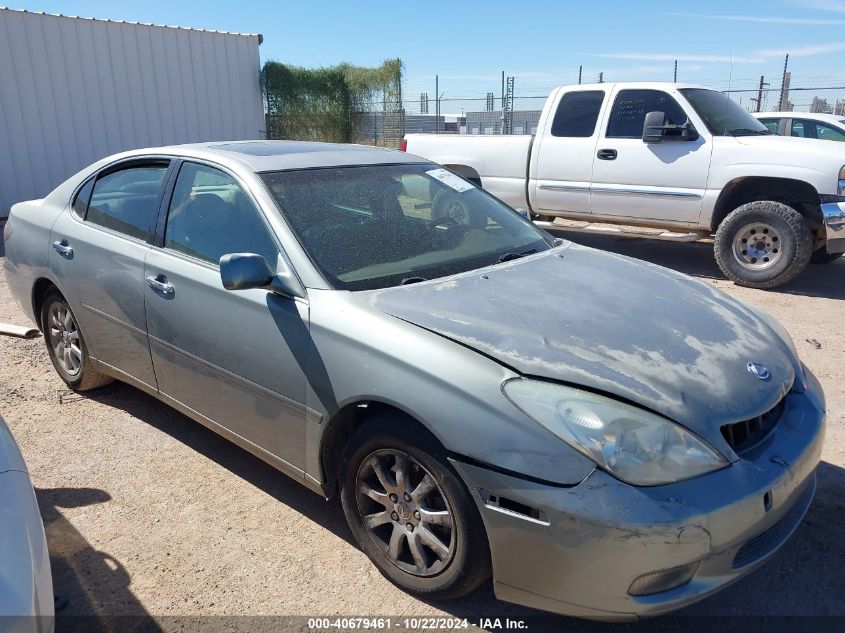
0 7 264 217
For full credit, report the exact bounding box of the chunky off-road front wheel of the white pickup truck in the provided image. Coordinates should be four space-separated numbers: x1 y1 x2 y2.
714 200 813 288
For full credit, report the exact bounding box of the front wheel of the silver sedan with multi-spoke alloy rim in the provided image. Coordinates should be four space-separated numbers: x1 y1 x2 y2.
341 415 491 600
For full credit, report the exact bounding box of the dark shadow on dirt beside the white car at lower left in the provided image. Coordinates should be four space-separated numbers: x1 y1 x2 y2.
35 488 161 633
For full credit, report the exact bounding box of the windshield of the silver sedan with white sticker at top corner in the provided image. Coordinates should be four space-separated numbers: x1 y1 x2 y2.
260 164 553 290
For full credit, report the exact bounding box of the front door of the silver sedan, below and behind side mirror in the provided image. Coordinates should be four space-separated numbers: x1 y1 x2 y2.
144 162 309 471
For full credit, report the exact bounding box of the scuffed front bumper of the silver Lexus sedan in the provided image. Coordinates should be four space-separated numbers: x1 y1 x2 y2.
453 372 825 620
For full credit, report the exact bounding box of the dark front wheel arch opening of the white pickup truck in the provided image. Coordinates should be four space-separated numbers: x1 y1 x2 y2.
710 176 821 231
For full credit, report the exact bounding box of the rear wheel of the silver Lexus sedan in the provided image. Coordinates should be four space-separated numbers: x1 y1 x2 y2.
41 288 114 391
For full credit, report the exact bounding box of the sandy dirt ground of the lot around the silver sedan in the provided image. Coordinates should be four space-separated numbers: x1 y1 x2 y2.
0 236 845 631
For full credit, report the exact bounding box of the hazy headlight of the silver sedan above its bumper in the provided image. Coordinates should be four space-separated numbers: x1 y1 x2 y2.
502 378 729 486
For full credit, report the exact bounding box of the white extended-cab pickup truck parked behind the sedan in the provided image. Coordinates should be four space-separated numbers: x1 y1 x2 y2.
402 83 845 288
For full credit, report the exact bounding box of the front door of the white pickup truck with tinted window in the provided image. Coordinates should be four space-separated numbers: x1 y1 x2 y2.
590 88 712 224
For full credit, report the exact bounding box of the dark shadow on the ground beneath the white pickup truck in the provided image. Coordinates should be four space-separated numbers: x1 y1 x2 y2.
552 229 845 300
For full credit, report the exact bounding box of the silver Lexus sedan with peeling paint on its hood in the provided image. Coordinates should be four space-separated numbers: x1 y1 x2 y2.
5 141 825 619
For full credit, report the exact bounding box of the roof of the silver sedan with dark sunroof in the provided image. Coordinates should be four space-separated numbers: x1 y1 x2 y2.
113 140 428 173
